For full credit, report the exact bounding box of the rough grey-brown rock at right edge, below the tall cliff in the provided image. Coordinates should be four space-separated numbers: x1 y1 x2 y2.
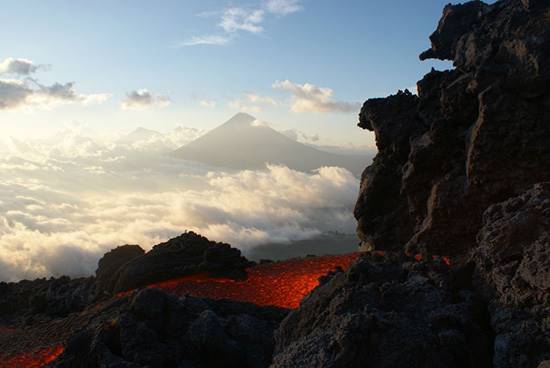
472 183 550 368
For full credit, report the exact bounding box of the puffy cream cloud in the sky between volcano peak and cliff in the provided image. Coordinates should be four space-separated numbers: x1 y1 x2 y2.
273 80 361 113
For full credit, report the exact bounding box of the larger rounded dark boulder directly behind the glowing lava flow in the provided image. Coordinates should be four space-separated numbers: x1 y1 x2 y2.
112 232 252 292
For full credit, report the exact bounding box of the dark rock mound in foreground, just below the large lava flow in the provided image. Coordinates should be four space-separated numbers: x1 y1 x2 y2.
49 289 286 368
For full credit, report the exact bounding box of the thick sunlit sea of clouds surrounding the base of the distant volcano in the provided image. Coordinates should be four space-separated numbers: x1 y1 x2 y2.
0 127 359 281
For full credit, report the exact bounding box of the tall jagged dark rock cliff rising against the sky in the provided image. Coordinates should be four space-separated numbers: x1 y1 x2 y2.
355 0 550 256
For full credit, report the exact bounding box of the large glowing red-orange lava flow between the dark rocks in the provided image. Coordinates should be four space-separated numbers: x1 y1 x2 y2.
141 253 359 308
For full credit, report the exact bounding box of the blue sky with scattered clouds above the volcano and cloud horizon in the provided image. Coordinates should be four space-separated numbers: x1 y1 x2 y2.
0 0 450 147
